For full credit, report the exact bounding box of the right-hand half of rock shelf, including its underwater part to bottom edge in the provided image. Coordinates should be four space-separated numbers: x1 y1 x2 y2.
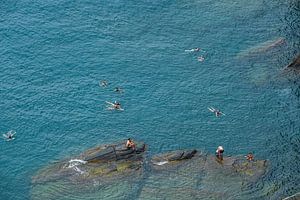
139 150 268 200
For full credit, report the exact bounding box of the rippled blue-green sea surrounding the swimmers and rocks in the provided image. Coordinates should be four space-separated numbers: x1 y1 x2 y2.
0 0 300 200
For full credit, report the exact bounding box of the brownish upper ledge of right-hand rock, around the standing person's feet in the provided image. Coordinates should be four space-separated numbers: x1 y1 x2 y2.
151 149 267 180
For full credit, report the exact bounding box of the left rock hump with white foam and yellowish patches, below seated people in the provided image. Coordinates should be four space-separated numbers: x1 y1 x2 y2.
32 142 146 183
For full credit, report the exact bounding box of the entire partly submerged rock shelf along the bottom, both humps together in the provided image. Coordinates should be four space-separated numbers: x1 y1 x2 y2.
32 142 268 199
